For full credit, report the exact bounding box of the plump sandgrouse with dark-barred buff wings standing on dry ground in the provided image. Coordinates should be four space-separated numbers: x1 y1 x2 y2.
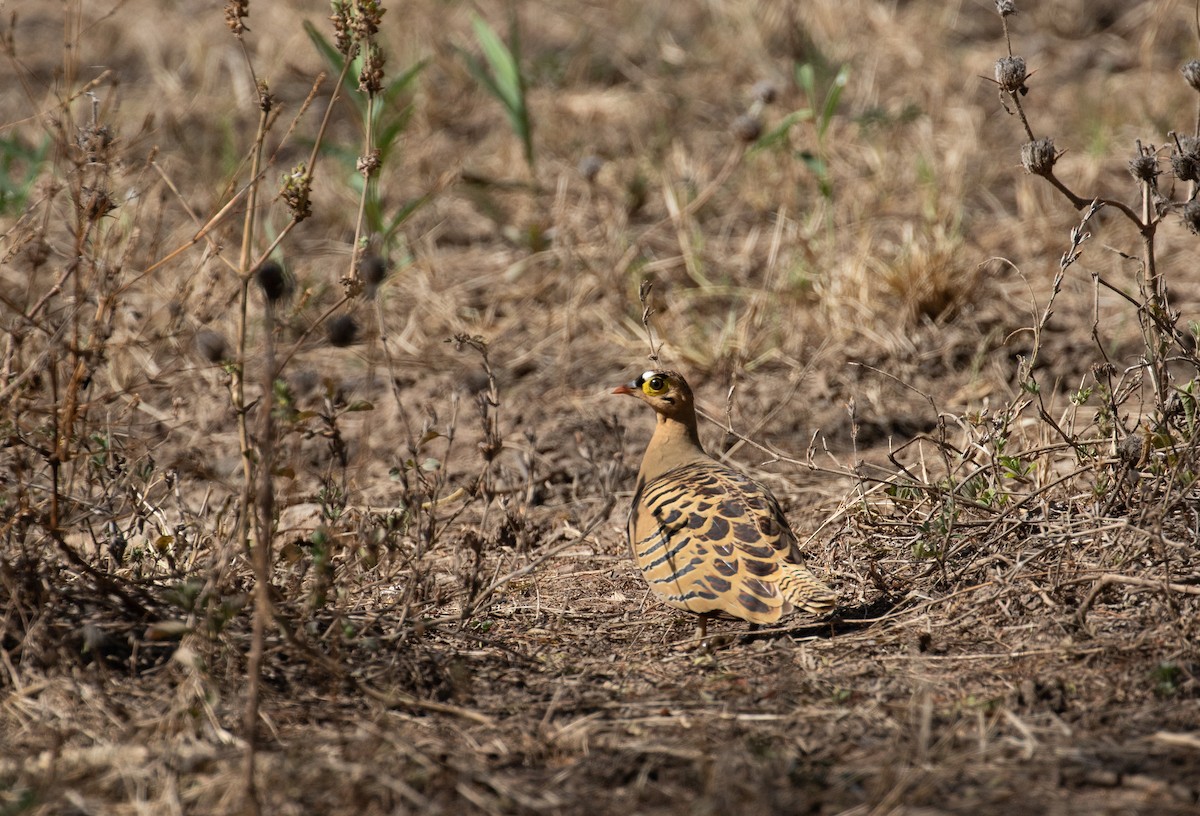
612 371 836 638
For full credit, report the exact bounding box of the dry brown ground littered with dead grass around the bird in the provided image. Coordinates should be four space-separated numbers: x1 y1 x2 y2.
0 0 1200 814
